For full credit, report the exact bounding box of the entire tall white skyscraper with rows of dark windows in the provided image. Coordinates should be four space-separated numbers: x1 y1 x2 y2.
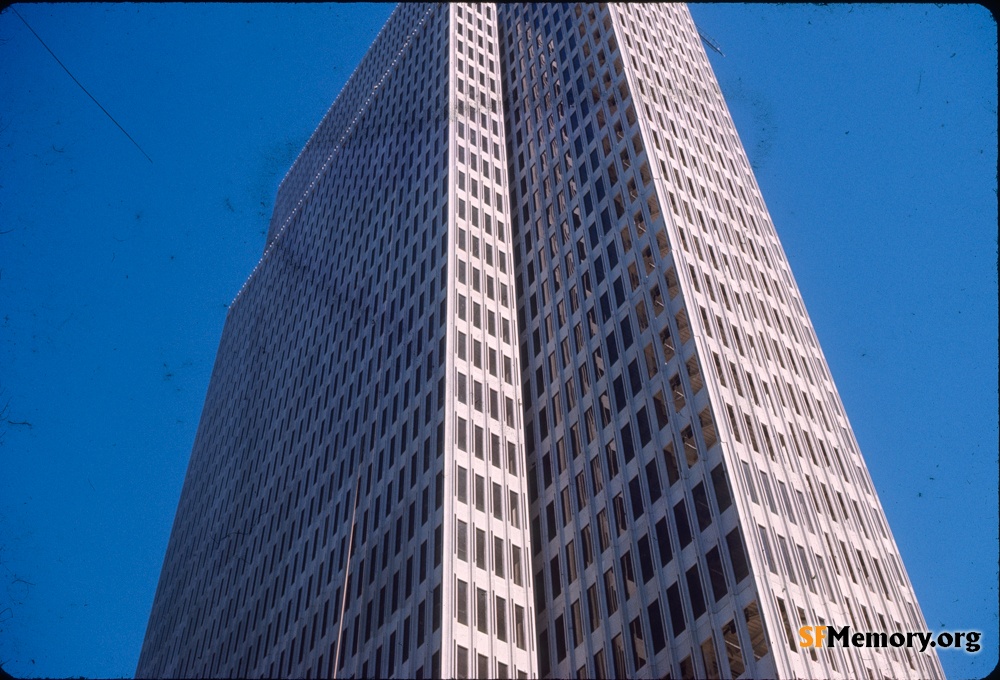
137 4 943 678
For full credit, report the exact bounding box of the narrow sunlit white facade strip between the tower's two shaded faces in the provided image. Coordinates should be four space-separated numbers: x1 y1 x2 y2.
442 5 536 677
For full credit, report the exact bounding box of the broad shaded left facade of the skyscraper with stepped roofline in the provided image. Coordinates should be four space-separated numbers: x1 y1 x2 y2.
138 5 450 677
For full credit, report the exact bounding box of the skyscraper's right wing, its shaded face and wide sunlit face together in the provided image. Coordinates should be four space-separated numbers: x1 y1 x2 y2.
500 5 938 677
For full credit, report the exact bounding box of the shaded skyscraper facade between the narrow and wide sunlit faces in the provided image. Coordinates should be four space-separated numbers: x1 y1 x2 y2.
501 7 753 676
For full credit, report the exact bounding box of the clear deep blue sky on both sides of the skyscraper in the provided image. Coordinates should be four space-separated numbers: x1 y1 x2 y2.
0 4 998 678
